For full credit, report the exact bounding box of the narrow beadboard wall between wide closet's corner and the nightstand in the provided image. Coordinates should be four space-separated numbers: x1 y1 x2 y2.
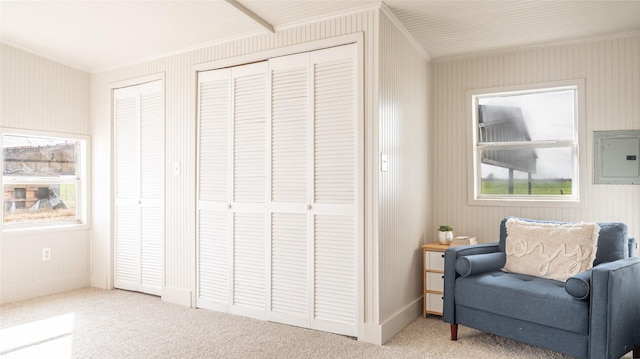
376 16 431 321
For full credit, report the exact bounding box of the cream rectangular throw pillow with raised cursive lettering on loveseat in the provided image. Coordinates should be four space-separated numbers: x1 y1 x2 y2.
502 218 600 282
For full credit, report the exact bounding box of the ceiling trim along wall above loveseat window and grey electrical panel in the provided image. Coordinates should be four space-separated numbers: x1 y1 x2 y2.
432 31 640 64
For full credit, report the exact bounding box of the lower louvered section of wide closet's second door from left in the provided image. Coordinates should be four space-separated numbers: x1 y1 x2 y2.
232 213 266 318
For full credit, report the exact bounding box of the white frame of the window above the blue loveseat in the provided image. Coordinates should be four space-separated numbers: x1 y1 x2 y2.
466 79 586 207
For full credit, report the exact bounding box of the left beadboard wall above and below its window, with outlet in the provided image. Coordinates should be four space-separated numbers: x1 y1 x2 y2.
0 44 91 303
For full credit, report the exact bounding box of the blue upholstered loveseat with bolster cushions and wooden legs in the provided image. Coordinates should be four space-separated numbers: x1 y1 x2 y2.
443 218 640 359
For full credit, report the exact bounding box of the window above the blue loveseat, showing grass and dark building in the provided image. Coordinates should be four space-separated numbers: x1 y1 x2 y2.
471 82 581 204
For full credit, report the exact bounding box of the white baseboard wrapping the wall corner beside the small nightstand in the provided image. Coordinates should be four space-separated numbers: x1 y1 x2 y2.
358 297 423 345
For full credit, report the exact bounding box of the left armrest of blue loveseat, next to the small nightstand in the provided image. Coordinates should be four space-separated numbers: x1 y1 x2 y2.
442 242 499 324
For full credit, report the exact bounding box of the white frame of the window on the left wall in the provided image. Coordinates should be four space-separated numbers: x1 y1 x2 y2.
0 127 91 232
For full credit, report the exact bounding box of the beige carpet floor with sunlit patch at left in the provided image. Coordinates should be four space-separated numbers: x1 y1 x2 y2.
0 288 631 359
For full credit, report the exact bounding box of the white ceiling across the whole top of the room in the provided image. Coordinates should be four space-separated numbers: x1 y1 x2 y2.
0 0 640 72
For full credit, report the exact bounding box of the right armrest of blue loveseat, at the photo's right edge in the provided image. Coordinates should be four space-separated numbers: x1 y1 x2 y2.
589 257 640 358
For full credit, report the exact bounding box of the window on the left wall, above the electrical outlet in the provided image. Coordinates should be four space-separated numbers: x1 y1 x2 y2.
0 129 87 228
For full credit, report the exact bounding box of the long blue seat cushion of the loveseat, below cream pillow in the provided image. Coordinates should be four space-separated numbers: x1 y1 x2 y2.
454 271 589 335
